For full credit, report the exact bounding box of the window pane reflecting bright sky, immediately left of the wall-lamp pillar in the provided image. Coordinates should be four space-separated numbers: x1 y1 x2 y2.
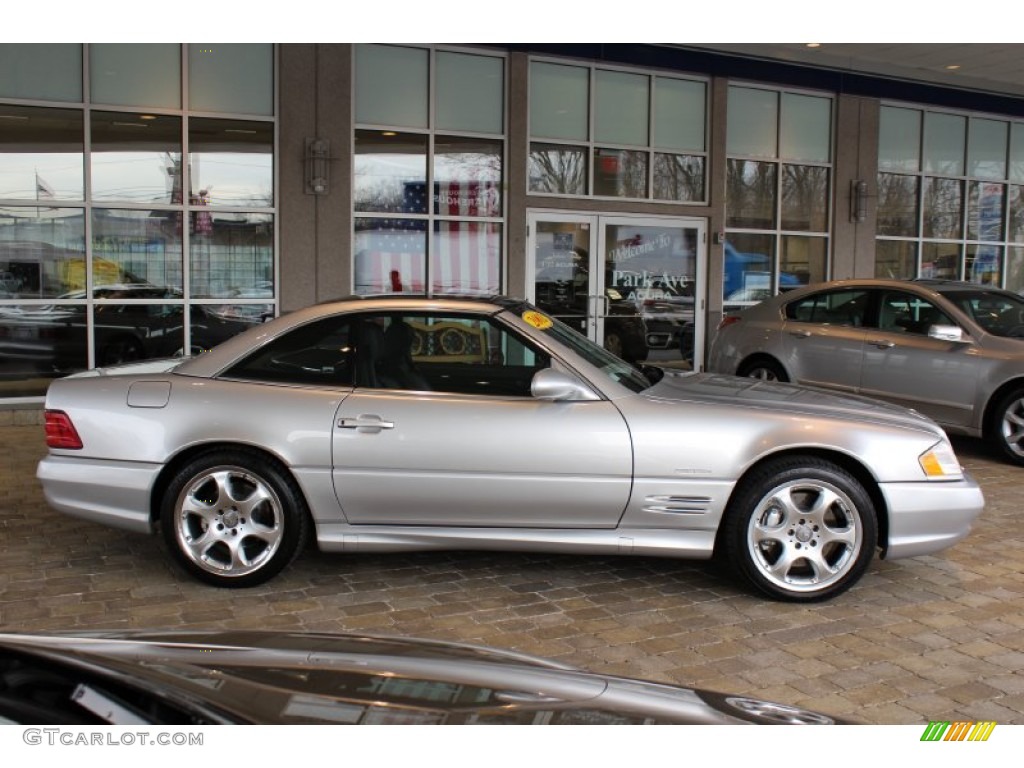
188 118 273 208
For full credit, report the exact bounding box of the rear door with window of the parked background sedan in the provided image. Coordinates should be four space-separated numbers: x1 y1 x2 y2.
781 288 869 392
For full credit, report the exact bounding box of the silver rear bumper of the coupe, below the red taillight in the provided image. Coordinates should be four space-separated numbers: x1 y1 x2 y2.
36 454 162 534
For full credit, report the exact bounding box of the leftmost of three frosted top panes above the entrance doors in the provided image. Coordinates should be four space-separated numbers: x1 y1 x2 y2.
529 61 590 141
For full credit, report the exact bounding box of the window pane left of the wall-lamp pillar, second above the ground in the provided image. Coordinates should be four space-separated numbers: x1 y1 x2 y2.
188 211 274 299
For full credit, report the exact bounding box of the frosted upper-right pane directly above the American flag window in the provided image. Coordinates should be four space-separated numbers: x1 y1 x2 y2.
435 51 505 133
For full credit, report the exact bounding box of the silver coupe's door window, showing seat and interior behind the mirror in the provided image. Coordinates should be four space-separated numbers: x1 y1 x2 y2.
352 311 551 397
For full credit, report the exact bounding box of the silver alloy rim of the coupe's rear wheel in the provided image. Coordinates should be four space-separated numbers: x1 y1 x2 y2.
174 466 285 578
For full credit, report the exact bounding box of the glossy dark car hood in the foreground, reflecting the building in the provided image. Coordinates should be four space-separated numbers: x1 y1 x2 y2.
0 631 839 725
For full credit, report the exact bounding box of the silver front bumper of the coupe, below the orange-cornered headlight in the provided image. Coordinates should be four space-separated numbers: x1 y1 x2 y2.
881 475 985 560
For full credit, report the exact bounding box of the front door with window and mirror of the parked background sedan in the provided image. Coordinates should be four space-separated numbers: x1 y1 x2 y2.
860 290 978 425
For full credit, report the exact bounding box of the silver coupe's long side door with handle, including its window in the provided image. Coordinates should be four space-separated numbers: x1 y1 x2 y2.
333 312 633 527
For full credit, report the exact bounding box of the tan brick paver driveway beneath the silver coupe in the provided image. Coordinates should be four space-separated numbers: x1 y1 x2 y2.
0 422 1024 724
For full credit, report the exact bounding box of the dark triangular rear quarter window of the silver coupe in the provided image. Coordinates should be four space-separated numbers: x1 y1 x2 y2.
224 315 354 387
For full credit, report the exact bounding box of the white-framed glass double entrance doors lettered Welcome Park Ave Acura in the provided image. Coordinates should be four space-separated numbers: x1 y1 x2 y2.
527 212 707 368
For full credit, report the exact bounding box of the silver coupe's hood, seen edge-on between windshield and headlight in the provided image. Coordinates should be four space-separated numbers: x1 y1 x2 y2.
643 371 945 438
